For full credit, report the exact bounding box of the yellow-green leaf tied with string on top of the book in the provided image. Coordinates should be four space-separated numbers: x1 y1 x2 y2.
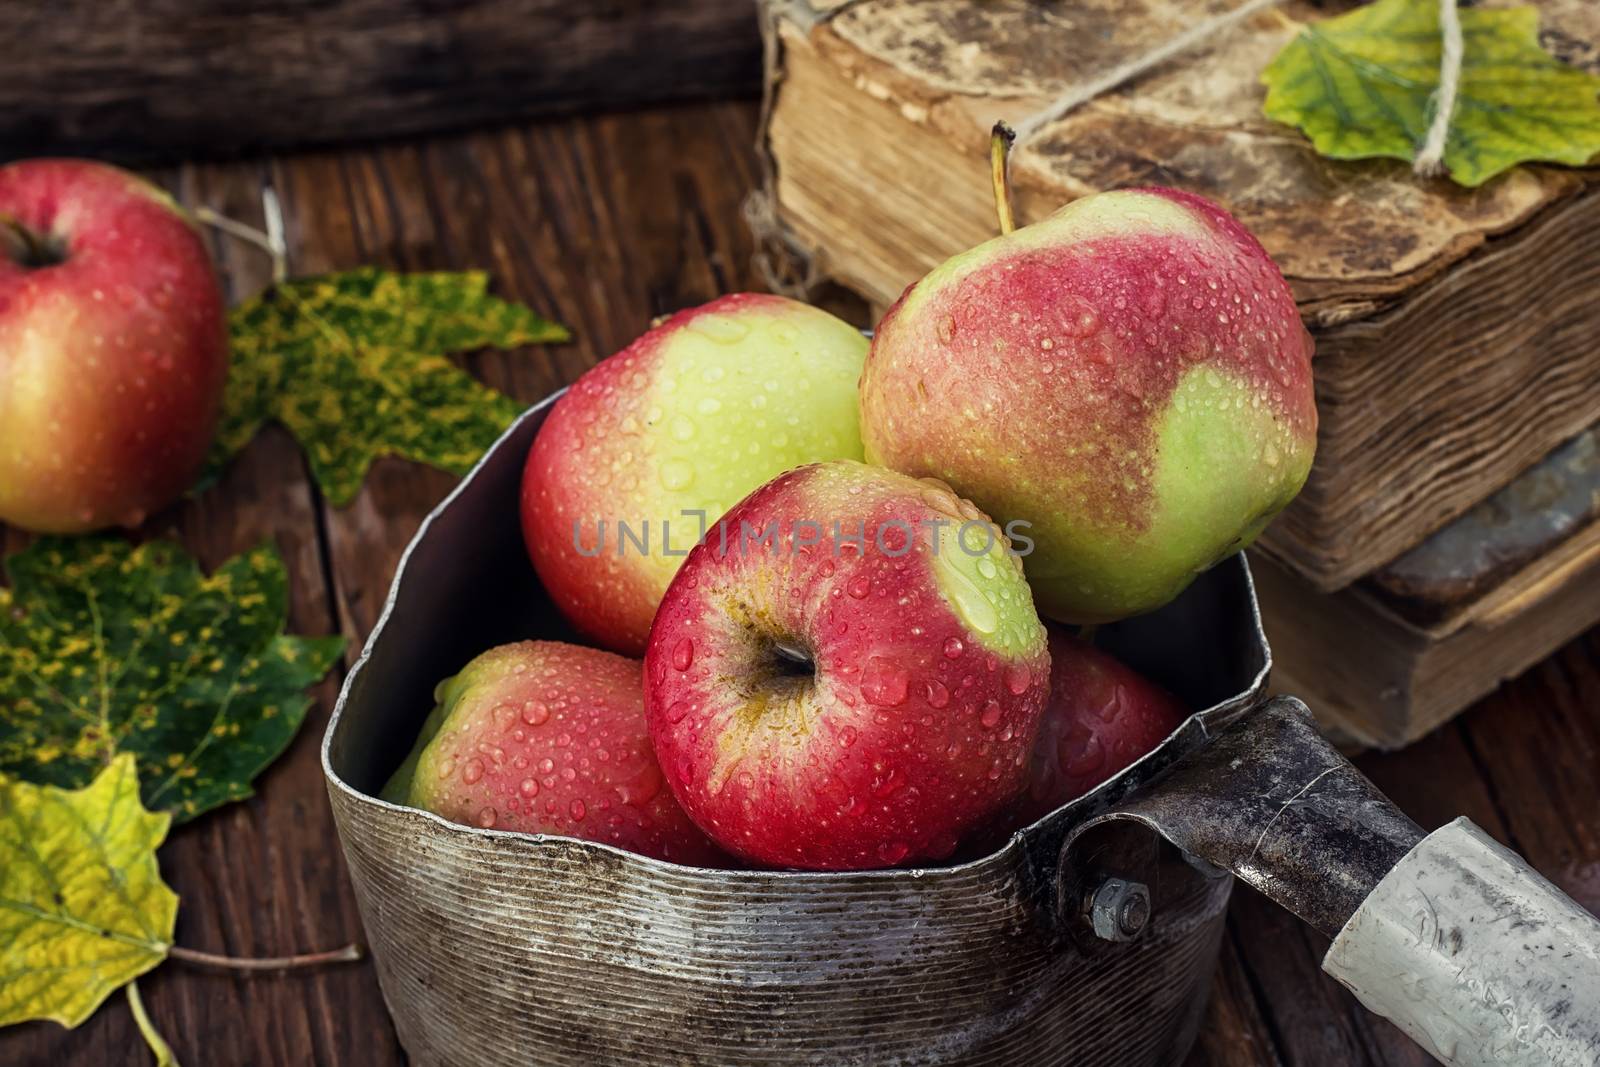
1261 0 1600 186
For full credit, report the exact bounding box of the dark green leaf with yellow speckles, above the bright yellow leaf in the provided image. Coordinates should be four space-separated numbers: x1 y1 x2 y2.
0 537 344 822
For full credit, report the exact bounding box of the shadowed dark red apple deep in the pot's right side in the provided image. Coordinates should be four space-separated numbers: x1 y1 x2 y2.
1006 627 1189 829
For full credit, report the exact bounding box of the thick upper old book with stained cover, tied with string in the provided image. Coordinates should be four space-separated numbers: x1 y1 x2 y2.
750 0 1600 590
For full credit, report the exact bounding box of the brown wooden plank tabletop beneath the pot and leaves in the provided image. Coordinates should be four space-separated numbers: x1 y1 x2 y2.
9 95 1600 1067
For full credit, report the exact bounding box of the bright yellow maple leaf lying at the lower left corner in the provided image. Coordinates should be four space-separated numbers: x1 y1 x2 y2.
0 755 178 1027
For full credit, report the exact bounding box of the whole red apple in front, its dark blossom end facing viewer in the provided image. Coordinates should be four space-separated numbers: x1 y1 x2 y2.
645 462 1050 870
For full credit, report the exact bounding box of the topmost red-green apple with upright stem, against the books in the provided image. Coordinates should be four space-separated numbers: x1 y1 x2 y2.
861 189 1317 622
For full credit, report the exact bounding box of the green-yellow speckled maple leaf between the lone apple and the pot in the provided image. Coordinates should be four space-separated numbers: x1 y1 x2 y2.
200 267 570 507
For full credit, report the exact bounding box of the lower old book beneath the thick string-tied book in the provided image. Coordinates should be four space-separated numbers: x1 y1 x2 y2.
1254 429 1600 749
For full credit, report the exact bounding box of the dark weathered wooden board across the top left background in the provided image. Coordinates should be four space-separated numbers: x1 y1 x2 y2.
0 0 760 162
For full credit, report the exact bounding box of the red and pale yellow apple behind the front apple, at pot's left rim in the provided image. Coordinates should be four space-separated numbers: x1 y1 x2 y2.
522 293 867 654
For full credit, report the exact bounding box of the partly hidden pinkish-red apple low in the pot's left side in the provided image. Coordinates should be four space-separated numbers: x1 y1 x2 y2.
384 641 725 865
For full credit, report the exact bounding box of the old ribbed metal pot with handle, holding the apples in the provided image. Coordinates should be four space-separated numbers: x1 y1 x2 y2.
323 397 1600 1067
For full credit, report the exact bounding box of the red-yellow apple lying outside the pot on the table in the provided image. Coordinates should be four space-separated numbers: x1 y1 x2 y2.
0 160 227 533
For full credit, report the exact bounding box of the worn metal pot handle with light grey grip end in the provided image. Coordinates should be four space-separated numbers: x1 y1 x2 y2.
1061 697 1600 1067
